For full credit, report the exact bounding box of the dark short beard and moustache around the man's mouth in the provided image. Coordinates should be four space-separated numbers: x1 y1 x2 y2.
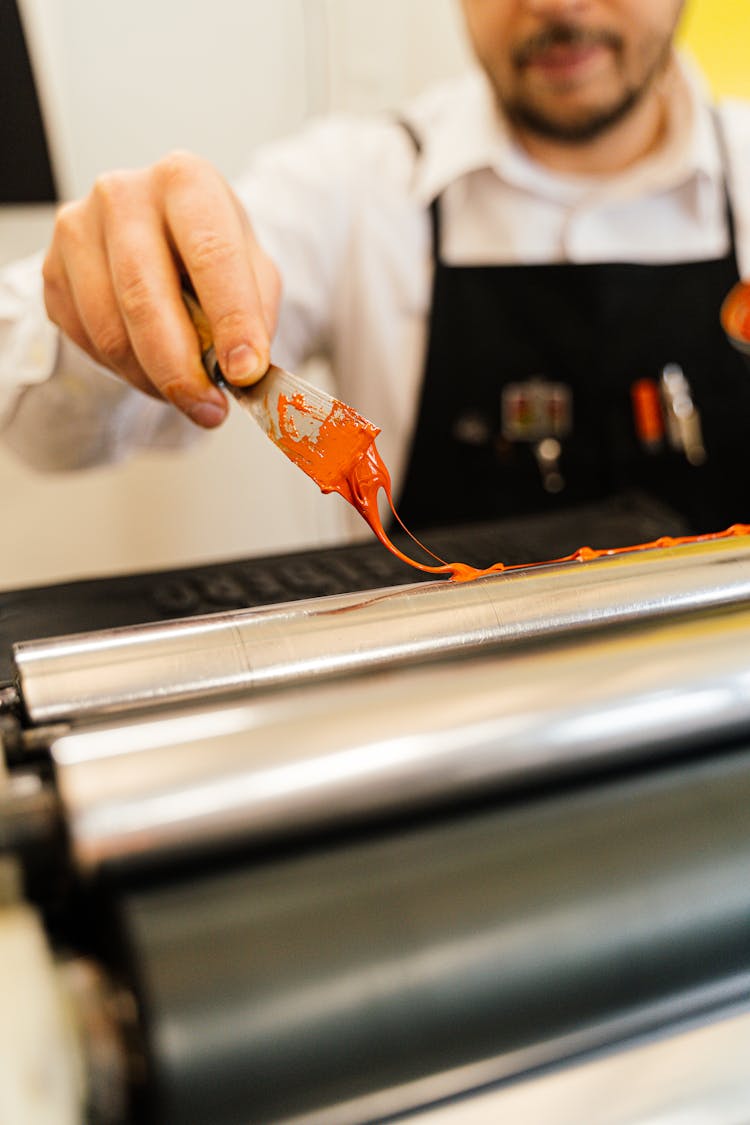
496 20 671 144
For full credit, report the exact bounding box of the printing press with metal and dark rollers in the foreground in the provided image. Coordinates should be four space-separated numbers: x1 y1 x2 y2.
0 504 750 1125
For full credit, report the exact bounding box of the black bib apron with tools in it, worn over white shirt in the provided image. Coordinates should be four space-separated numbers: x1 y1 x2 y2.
397 123 750 533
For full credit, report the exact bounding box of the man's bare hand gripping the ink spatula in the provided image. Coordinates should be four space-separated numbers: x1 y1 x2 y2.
44 153 281 426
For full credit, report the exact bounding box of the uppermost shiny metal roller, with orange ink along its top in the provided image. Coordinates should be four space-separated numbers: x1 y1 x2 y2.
15 537 750 723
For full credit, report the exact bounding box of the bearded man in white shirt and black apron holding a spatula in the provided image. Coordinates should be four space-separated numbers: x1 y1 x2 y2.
1 0 750 531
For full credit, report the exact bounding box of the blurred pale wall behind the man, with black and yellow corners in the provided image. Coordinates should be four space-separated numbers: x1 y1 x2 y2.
0 0 750 588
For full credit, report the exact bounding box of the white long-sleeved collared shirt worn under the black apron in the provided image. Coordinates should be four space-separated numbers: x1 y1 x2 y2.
0 51 750 501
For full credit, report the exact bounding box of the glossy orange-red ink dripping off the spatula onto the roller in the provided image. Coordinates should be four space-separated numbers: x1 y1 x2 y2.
269 395 750 582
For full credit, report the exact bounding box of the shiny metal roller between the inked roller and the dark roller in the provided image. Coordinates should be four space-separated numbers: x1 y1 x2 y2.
51 609 750 873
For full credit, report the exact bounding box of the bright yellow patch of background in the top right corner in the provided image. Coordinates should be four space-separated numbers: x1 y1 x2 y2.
680 0 750 98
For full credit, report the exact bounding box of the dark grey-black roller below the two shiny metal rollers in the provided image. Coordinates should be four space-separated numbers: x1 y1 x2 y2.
114 750 750 1125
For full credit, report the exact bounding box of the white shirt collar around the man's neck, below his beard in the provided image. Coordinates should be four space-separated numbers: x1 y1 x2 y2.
409 53 723 205
